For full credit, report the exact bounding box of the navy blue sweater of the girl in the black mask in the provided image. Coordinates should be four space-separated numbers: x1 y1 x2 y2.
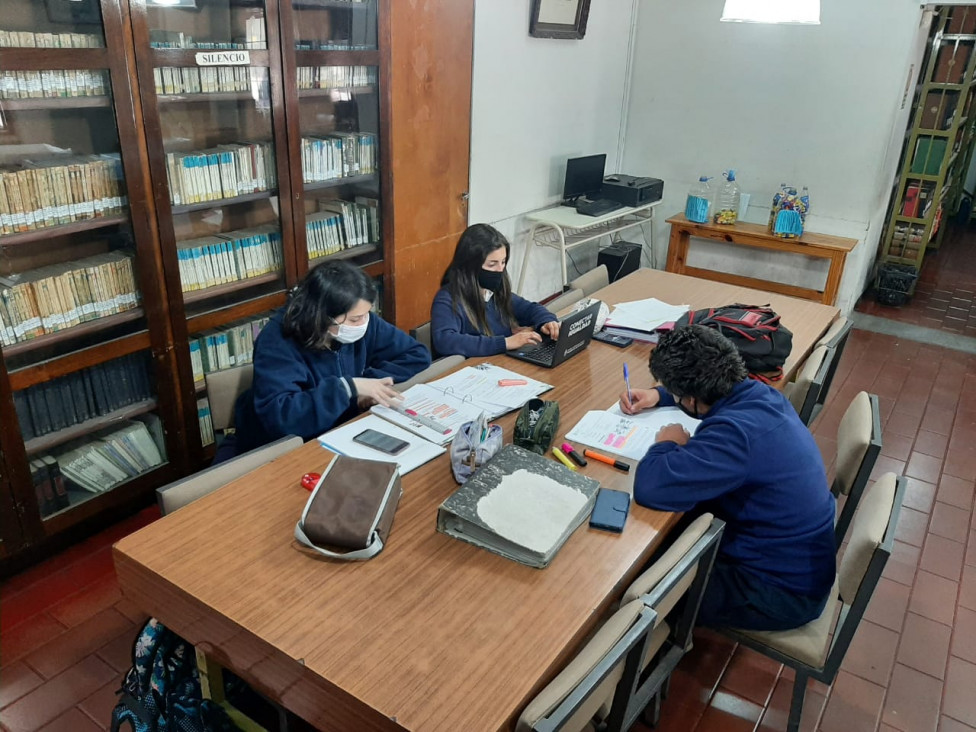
430 287 556 358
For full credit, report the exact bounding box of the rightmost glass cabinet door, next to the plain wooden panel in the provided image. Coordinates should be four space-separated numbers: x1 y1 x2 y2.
282 0 383 275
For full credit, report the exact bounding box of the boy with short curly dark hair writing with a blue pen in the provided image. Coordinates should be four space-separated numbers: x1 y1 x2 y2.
620 325 835 630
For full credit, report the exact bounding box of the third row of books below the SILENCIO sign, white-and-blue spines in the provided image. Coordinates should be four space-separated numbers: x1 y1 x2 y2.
176 224 283 292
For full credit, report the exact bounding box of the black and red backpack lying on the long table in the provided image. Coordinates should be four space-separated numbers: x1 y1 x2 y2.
674 303 793 382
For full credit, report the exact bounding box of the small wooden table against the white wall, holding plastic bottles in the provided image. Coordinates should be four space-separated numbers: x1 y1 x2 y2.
665 214 857 305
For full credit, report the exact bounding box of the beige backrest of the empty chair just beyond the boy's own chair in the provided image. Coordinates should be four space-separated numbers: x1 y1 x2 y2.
831 391 882 546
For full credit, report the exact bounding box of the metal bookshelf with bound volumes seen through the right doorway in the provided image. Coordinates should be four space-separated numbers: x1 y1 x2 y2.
879 6 976 287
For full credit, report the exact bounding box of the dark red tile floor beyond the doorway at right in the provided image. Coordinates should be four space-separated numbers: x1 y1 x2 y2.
856 217 976 336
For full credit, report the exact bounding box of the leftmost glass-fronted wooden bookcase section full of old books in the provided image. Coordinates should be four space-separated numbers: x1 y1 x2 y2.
0 0 187 568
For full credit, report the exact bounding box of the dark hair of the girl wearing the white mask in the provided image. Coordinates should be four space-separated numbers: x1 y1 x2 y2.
281 260 376 351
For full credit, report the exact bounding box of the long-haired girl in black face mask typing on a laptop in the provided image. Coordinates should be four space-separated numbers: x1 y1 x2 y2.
430 224 559 358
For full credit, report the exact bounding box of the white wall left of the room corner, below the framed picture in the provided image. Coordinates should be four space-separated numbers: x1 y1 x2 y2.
468 0 634 298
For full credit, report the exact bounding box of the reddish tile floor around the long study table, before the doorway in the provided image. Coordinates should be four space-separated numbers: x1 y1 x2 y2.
0 330 976 732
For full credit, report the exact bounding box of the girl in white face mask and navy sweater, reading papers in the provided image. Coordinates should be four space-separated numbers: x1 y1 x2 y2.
234 261 430 454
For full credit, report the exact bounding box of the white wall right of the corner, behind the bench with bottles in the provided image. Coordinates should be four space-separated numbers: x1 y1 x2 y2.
622 0 922 310
